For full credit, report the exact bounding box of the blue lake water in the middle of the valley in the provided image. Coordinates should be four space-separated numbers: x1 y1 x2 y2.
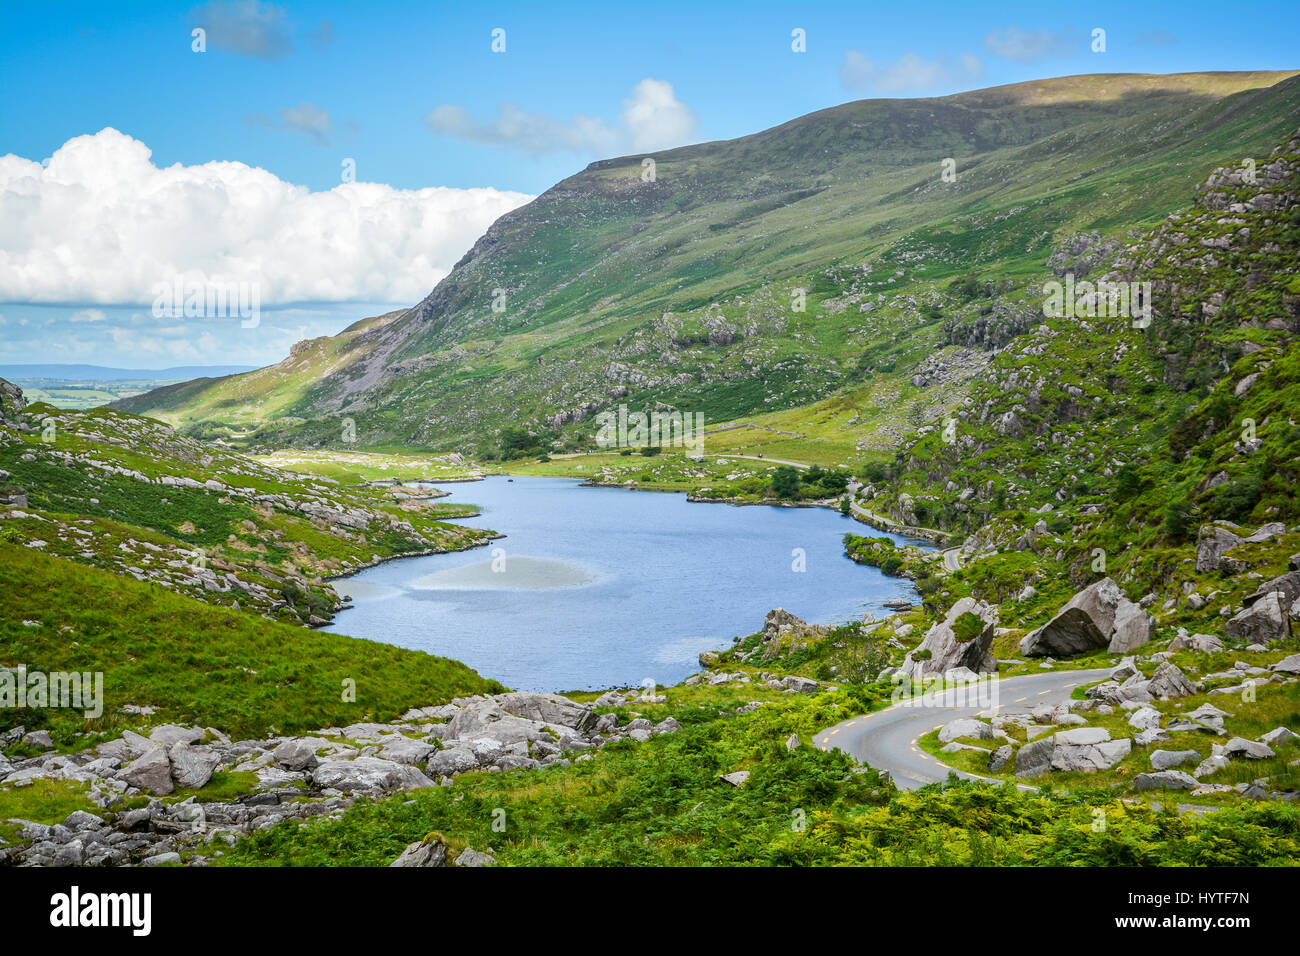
326 477 915 691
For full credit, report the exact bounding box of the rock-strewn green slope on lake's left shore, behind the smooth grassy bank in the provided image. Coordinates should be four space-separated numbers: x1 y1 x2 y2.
0 380 493 624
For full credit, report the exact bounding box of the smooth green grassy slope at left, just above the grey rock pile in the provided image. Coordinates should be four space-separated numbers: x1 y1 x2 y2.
0 542 503 749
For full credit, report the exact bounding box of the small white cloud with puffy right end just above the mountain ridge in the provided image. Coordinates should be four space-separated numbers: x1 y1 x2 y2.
424 77 698 156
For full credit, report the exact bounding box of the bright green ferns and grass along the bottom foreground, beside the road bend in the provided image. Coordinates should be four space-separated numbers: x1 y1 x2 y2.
216 691 1300 866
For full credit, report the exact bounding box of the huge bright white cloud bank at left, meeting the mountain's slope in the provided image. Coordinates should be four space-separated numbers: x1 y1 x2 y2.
0 129 532 306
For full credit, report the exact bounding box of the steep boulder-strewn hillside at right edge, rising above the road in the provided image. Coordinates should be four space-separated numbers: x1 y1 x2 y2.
870 128 1300 600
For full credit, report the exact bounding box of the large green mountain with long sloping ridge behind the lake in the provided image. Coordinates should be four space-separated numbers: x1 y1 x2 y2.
116 73 1300 453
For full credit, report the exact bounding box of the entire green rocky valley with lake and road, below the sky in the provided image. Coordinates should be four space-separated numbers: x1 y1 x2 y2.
0 73 1300 866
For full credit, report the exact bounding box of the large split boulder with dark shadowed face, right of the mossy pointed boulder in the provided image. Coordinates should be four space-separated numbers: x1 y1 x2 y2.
1021 578 1154 657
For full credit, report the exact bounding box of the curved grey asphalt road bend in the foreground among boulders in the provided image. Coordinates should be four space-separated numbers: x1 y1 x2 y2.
813 670 1106 790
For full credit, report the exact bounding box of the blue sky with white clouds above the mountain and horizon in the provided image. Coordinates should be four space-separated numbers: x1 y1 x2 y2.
0 0 1300 368
